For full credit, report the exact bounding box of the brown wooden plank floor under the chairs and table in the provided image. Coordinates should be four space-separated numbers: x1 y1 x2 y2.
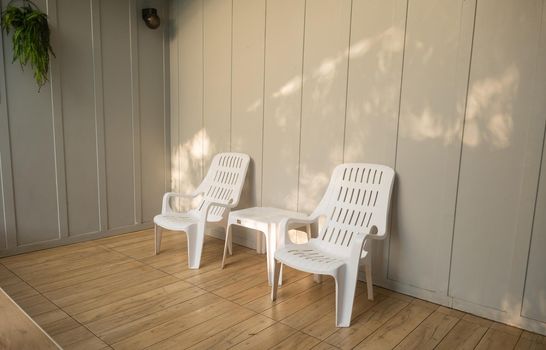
0 230 546 350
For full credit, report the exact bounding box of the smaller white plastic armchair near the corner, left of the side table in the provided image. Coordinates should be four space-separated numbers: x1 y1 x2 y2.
154 153 250 269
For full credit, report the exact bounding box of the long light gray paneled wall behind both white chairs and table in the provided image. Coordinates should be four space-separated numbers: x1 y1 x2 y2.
170 0 546 333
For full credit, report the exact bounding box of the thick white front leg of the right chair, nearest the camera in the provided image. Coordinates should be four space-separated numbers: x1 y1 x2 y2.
334 267 357 327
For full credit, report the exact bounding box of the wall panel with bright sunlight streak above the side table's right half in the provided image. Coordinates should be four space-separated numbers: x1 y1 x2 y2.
262 0 305 210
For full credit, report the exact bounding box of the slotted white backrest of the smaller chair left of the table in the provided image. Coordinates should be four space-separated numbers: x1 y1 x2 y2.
196 153 250 216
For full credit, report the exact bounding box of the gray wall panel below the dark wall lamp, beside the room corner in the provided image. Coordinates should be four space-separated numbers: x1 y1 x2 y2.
137 0 167 222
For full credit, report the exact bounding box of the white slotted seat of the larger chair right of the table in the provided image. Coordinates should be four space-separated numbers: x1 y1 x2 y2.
275 243 345 275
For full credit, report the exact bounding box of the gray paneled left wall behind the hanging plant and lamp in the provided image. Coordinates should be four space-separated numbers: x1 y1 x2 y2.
0 0 170 256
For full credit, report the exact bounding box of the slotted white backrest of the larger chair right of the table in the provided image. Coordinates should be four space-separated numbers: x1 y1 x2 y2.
312 163 394 253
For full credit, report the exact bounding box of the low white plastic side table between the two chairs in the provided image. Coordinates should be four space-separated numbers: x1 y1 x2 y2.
222 207 311 285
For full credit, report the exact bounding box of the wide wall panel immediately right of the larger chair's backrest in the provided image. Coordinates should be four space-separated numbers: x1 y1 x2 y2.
388 0 475 292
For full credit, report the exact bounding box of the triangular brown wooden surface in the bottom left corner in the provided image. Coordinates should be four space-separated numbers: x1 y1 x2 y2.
0 288 60 349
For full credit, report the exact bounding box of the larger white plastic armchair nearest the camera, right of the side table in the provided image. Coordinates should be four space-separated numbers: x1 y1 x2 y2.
271 164 394 327
